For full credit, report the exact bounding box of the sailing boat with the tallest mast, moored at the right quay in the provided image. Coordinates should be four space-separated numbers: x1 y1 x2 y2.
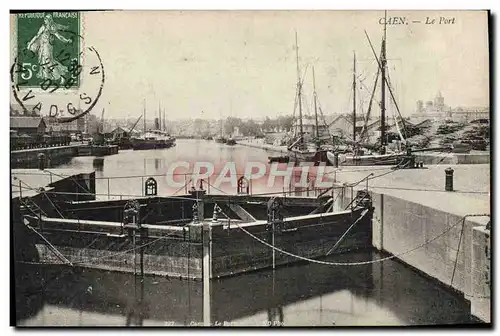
327 14 411 166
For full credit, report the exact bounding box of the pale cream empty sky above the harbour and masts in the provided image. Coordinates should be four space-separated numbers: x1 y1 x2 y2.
11 11 489 119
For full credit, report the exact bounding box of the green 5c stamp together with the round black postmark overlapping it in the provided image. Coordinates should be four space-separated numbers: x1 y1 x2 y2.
10 12 105 123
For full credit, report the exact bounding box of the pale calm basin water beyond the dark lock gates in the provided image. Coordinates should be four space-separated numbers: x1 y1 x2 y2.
55 139 290 199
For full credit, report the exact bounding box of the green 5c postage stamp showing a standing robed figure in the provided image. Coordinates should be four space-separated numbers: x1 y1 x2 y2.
16 12 82 89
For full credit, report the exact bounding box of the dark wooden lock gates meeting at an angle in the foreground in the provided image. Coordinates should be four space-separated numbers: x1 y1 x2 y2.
13 169 373 279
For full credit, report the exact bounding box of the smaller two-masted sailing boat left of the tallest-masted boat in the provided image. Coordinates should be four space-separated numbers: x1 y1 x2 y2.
287 32 319 162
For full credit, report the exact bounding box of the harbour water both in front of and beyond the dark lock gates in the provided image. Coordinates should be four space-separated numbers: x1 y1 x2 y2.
16 140 476 326
